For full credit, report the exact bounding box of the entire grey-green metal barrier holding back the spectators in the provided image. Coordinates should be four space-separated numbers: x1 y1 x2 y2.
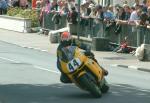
43 13 150 47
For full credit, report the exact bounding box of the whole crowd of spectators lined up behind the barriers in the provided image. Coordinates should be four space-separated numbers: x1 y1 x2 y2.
0 0 150 29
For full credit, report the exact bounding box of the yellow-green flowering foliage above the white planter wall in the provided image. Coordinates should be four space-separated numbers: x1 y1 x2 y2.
7 8 39 27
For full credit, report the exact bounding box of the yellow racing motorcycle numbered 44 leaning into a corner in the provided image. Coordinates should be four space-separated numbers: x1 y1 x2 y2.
60 46 109 97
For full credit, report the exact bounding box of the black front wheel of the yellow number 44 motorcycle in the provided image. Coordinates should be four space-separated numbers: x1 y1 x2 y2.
79 75 102 98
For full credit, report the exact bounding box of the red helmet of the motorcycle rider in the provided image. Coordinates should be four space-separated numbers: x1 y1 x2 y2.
60 31 71 46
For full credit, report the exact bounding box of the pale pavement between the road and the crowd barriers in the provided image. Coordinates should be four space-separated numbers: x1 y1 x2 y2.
0 29 150 72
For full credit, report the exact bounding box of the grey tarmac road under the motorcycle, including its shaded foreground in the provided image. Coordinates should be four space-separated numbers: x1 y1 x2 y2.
0 41 150 103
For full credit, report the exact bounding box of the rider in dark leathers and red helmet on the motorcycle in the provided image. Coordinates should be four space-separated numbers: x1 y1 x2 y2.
57 31 108 83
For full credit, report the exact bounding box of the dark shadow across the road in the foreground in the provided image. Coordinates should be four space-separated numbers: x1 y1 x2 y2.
0 84 150 103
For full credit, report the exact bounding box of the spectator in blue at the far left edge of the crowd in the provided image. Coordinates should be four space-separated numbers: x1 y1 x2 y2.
0 0 8 15
